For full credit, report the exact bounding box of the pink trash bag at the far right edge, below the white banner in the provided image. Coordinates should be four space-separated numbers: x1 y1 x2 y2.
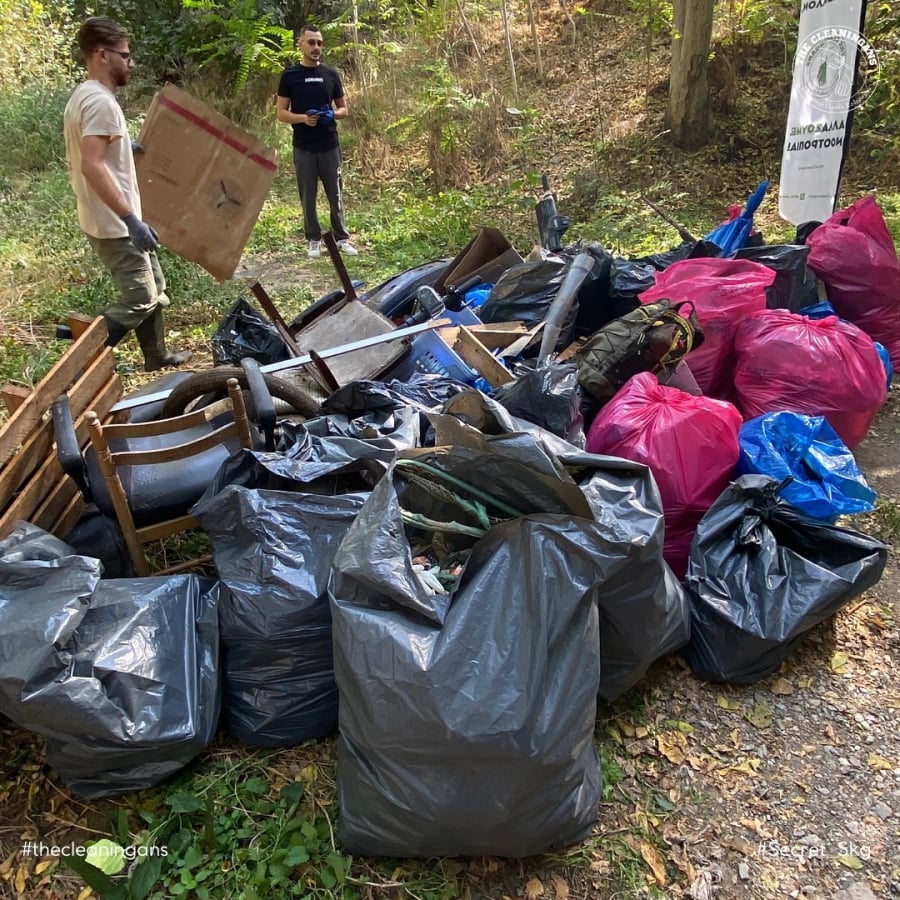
804 195 900 367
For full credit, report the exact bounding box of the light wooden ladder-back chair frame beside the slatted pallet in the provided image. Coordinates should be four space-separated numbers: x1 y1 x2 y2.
85 378 253 575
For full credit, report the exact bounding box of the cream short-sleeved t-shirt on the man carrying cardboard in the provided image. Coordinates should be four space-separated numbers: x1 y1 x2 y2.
63 80 142 239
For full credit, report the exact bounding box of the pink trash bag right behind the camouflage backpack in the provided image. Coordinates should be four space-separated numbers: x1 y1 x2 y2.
639 257 775 398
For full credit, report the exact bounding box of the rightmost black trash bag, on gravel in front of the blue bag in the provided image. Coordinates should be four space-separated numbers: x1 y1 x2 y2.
685 475 887 684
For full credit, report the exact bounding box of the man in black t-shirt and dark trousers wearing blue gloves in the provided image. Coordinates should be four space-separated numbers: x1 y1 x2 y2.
276 25 357 259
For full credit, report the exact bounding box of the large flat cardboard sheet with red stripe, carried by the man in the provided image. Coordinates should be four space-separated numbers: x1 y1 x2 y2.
135 84 276 281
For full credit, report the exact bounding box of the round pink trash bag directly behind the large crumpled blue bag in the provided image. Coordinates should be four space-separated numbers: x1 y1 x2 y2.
734 309 887 450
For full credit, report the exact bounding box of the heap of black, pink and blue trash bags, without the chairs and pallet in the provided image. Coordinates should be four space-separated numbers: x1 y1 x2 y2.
0 185 900 857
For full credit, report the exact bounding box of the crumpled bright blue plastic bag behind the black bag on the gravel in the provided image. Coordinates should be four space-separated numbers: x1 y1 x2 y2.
735 412 875 523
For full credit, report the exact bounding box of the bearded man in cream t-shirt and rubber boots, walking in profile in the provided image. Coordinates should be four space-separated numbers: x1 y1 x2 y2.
63 16 193 372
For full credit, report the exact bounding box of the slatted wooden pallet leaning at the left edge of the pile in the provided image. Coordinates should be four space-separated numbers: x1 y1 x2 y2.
0 315 124 538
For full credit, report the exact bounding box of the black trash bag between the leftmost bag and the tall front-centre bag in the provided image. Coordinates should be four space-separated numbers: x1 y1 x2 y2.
193 486 368 747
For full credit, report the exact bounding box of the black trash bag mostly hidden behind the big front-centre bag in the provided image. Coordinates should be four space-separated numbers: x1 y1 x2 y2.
432 391 690 701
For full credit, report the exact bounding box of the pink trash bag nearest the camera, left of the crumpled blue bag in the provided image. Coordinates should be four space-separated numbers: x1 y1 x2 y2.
587 372 743 579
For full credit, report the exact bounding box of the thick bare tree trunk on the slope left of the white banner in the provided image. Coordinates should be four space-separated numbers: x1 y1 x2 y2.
666 0 713 150
